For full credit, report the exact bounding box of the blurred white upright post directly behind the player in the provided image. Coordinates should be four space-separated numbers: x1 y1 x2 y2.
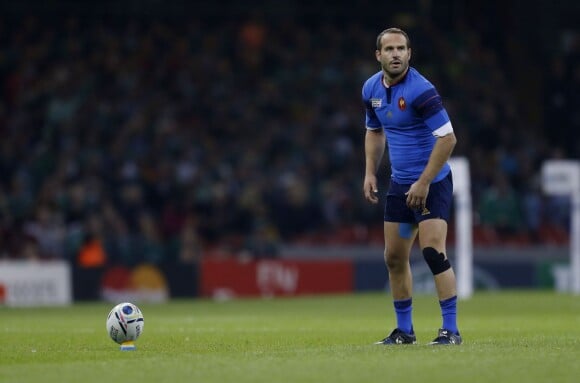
449 157 474 299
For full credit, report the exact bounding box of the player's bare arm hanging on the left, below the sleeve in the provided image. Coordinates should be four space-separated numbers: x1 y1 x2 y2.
363 127 385 203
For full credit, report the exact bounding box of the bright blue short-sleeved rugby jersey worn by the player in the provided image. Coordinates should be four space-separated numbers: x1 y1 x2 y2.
362 67 450 184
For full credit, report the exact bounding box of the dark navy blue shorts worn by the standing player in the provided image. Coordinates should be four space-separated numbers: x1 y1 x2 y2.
384 172 453 223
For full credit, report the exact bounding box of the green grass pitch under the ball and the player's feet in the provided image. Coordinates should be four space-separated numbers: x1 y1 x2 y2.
0 291 580 383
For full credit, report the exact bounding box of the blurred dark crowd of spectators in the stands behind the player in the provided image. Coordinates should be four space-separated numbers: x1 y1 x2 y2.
0 1 580 267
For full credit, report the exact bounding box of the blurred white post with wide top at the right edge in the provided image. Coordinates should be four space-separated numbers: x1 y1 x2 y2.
542 160 580 294
